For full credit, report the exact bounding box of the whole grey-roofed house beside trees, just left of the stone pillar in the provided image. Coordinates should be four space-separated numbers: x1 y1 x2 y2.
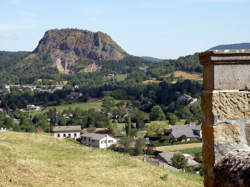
168 125 202 141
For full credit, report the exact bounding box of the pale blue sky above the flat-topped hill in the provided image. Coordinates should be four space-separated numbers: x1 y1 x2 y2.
0 0 250 59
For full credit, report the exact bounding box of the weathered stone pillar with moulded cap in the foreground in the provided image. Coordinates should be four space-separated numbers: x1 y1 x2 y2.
200 50 250 187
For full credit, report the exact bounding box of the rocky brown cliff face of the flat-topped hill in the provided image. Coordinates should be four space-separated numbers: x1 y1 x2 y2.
28 29 127 74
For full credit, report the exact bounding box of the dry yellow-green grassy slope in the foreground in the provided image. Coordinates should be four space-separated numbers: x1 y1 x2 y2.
0 132 203 187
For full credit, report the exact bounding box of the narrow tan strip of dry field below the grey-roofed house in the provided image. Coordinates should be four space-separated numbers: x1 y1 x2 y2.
155 143 202 151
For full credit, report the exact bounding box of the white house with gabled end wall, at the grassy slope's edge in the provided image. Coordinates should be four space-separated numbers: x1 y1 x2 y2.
81 133 117 149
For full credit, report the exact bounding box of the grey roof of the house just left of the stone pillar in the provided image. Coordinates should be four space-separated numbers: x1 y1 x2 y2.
169 125 201 138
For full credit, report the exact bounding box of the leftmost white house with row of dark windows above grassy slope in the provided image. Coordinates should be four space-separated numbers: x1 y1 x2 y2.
52 126 81 139
